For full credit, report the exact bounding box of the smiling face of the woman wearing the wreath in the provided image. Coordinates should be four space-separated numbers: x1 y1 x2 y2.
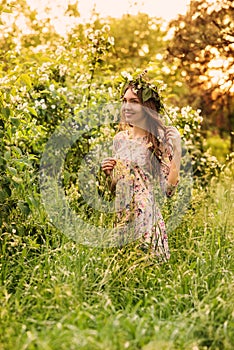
122 88 145 127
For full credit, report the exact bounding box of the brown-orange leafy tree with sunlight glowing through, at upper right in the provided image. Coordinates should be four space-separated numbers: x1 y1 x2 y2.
168 0 234 150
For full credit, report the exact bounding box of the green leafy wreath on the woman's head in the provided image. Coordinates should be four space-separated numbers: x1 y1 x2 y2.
120 69 164 112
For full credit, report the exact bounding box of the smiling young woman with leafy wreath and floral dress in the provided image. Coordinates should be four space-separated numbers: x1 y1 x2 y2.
102 76 181 260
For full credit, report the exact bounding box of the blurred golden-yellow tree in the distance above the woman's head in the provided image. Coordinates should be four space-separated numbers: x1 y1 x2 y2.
109 13 166 69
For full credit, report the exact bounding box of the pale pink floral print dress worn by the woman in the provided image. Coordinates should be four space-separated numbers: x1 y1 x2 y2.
113 130 176 260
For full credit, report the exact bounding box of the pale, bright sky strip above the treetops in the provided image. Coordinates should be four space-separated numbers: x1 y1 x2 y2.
27 0 190 34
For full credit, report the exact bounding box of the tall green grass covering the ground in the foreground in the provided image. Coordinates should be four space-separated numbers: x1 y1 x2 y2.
0 172 234 350
